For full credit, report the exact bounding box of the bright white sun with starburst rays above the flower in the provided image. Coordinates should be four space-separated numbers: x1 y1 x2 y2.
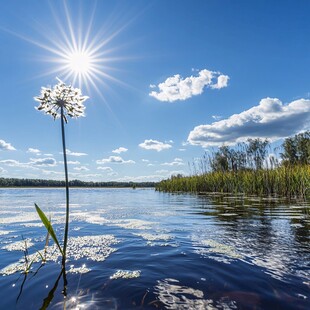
13 1 128 97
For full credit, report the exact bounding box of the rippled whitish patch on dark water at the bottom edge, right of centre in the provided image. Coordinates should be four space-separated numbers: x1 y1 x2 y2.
154 279 237 310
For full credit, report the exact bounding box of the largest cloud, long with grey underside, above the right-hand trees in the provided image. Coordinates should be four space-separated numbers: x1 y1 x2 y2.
187 98 310 147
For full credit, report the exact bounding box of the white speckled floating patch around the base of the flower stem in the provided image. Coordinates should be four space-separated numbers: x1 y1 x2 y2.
0 235 119 275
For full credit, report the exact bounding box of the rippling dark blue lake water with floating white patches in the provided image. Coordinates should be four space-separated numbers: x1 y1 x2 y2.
0 188 310 309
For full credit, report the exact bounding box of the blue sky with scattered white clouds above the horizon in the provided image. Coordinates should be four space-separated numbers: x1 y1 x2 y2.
0 0 310 181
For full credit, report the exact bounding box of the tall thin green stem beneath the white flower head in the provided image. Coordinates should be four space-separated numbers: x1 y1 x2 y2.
60 107 69 267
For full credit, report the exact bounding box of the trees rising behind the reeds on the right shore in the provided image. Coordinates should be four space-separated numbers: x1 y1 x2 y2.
192 131 310 174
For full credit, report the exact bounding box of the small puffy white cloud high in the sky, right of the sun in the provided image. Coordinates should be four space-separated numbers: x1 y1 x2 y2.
149 69 229 102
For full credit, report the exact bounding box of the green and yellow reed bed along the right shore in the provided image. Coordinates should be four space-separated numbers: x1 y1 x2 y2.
156 165 310 197
